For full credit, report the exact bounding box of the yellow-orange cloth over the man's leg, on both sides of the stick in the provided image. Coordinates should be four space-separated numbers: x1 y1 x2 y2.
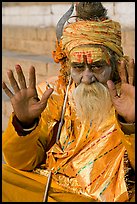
2 164 95 202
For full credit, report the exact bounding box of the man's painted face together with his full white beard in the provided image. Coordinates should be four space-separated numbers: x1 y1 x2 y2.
69 47 112 126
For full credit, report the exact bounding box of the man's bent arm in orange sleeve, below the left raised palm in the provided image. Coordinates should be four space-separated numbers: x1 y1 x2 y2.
2 78 64 170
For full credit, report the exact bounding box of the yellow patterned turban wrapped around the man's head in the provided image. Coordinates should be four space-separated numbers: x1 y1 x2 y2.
61 20 123 57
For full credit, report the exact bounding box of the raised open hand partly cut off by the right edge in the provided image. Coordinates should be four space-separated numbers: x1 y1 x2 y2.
107 59 135 123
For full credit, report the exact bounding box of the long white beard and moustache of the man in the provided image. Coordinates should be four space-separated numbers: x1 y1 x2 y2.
72 82 112 125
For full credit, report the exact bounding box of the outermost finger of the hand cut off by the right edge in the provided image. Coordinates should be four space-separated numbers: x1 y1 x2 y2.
128 59 135 85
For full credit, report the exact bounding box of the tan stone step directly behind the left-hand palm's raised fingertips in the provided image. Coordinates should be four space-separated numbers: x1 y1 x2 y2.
2 50 60 83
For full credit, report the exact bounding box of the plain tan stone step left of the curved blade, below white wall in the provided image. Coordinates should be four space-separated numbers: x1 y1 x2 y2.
2 25 56 55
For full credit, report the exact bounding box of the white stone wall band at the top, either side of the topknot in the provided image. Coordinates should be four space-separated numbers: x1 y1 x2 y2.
2 2 135 29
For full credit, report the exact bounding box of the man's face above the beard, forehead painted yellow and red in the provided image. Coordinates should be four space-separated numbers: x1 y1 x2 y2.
70 47 112 85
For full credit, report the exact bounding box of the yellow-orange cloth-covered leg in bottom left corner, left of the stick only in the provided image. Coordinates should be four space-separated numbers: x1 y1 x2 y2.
2 165 45 202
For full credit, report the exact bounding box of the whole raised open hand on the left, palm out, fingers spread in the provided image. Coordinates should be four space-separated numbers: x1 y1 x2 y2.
2 65 53 126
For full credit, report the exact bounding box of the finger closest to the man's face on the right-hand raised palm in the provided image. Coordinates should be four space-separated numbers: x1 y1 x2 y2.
118 60 127 83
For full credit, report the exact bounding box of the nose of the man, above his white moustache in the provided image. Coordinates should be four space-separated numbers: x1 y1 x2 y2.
81 67 96 84
